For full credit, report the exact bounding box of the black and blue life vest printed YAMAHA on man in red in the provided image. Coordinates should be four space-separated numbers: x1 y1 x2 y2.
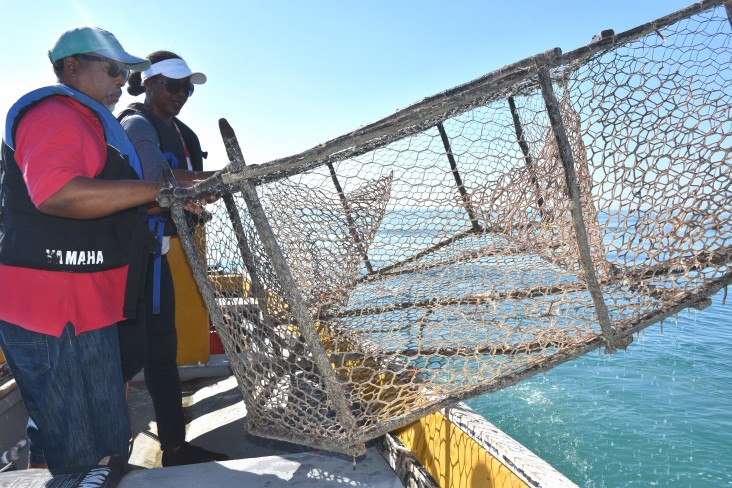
0 84 159 317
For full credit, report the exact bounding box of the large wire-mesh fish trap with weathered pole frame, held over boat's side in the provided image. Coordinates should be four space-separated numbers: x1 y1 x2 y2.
160 0 732 454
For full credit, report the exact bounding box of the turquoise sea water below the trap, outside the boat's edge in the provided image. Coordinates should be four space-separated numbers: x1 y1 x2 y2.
466 290 732 488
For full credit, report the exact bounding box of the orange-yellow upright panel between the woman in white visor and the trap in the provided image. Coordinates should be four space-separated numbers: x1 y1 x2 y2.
167 236 210 364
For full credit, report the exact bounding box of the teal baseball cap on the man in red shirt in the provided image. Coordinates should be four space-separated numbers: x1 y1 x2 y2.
48 26 150 71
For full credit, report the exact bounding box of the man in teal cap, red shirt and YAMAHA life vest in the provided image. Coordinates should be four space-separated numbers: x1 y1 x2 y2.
0 27 203 472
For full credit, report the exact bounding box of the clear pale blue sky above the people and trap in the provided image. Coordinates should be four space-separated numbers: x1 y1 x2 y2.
0 0 692 169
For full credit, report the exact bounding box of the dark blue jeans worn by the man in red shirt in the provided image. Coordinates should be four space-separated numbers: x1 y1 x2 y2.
0 320 131 472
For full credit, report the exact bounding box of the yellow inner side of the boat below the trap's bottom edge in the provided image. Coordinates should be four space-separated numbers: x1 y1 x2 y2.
394 412 528 488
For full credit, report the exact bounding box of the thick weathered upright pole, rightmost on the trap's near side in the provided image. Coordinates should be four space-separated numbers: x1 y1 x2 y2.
537 61 615 353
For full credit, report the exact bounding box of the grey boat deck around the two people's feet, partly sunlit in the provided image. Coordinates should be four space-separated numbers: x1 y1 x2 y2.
0 358 403 488
